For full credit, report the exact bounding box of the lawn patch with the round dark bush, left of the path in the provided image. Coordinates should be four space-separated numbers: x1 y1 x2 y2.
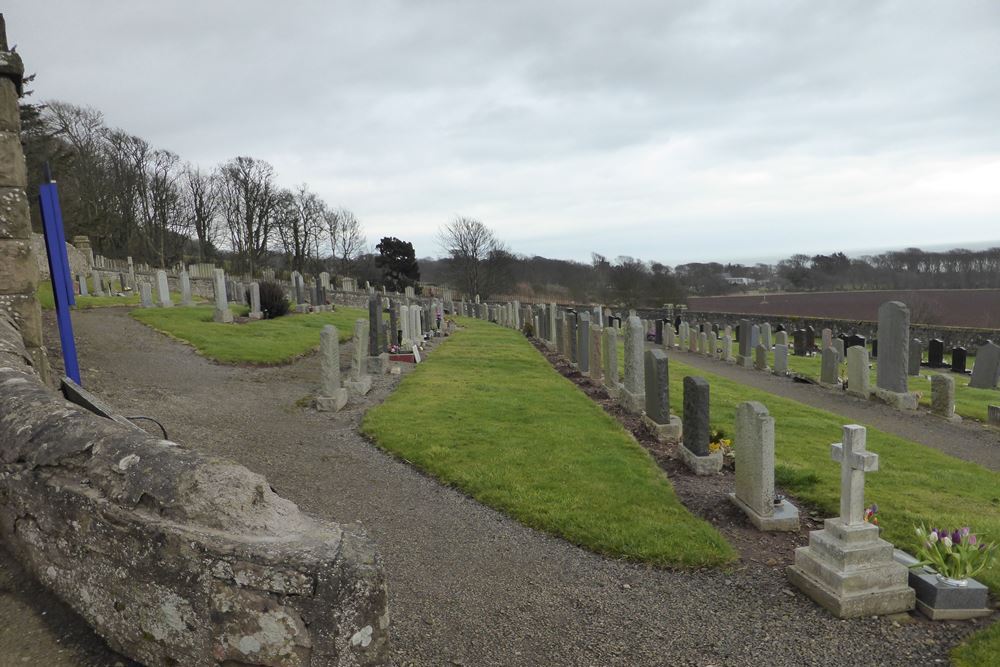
130 305 368 364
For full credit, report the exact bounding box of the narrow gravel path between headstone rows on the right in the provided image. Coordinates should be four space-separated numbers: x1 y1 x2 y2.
647 344 1000 471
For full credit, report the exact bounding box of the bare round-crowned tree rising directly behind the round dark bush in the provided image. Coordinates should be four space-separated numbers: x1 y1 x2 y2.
219 157 278 275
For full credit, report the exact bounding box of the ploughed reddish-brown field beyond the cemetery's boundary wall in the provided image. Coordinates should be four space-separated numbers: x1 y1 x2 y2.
688 289 1000 329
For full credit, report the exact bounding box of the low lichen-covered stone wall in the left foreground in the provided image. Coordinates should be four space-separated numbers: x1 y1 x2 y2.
0 317 388 667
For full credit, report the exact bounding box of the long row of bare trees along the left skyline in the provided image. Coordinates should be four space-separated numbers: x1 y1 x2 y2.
22 102 366 273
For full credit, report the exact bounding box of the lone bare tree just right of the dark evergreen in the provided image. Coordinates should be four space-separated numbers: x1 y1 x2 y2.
439 216 514 298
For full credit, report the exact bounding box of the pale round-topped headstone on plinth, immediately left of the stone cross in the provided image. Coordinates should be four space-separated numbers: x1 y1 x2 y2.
729 401 799 531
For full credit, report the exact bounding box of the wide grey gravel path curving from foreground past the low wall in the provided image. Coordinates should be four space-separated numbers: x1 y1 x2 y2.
0 310 983 667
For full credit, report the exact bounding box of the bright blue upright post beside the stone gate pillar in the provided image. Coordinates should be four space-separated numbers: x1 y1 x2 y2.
38 181 83 385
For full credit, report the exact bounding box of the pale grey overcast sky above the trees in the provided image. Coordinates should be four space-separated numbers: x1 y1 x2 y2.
3 0 1000 264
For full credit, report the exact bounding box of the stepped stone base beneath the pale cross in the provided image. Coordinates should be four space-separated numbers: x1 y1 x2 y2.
787 517 916 618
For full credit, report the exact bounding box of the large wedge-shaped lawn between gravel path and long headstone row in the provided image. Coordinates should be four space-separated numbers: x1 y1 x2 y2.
362 318 735 566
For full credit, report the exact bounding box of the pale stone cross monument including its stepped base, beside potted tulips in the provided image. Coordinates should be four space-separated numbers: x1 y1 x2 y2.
787 426 916 618
